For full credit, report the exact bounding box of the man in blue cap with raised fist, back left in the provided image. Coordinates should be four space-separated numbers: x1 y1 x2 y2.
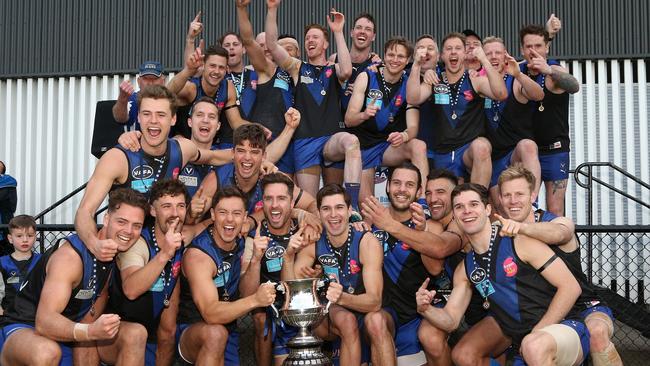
113 61 165 131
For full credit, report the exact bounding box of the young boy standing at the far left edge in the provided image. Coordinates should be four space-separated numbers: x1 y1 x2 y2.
0 215 40 314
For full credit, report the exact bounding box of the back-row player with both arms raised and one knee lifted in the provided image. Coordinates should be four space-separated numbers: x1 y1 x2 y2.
265 0 362 214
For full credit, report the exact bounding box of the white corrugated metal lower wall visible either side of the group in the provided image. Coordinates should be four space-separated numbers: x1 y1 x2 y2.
0 60 650 225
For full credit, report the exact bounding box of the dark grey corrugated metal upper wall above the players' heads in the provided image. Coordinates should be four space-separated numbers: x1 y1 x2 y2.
0 0 650 78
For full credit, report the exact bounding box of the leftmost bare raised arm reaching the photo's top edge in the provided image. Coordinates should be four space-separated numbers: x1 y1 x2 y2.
235 0 275 78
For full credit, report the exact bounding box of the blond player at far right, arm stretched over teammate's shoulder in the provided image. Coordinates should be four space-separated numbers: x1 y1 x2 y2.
496 166 623 366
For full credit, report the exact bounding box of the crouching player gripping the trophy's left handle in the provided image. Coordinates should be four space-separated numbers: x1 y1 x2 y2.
178 187 275 365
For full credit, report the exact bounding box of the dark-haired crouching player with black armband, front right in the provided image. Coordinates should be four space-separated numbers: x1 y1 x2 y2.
416 183 589 365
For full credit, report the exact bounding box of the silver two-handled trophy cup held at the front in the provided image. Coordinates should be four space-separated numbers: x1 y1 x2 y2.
271 278 332 366
